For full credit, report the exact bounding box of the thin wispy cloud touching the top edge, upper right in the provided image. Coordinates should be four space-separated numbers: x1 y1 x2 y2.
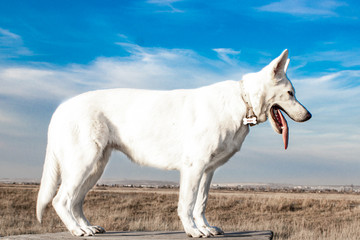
258 0 347 17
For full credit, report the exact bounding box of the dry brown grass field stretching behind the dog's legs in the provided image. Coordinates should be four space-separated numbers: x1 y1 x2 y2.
0 184 360 240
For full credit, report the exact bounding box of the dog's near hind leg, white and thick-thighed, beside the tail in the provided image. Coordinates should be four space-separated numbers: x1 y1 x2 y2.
53 142 105 236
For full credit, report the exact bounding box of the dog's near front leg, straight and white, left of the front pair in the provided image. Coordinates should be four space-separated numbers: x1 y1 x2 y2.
178 165 211 238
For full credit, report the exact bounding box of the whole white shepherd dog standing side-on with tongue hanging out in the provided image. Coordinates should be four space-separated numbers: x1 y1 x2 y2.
37 50 311 237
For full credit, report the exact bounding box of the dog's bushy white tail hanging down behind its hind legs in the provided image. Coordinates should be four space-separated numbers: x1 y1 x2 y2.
36 144 60 223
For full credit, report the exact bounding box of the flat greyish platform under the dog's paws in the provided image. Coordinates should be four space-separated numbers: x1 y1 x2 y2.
4 231 273 240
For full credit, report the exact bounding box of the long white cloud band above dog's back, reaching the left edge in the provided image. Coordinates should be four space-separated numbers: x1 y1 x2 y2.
0 43 236 100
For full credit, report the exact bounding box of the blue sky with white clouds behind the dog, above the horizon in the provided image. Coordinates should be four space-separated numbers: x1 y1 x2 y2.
0 0 360 184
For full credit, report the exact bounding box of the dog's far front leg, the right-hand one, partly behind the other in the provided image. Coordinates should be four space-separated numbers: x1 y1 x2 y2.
193 170 224 235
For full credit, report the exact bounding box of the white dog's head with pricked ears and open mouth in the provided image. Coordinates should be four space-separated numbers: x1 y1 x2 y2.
243 50 311 148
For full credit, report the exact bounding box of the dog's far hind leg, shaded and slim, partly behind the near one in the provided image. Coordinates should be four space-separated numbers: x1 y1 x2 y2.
73 147 112 233
